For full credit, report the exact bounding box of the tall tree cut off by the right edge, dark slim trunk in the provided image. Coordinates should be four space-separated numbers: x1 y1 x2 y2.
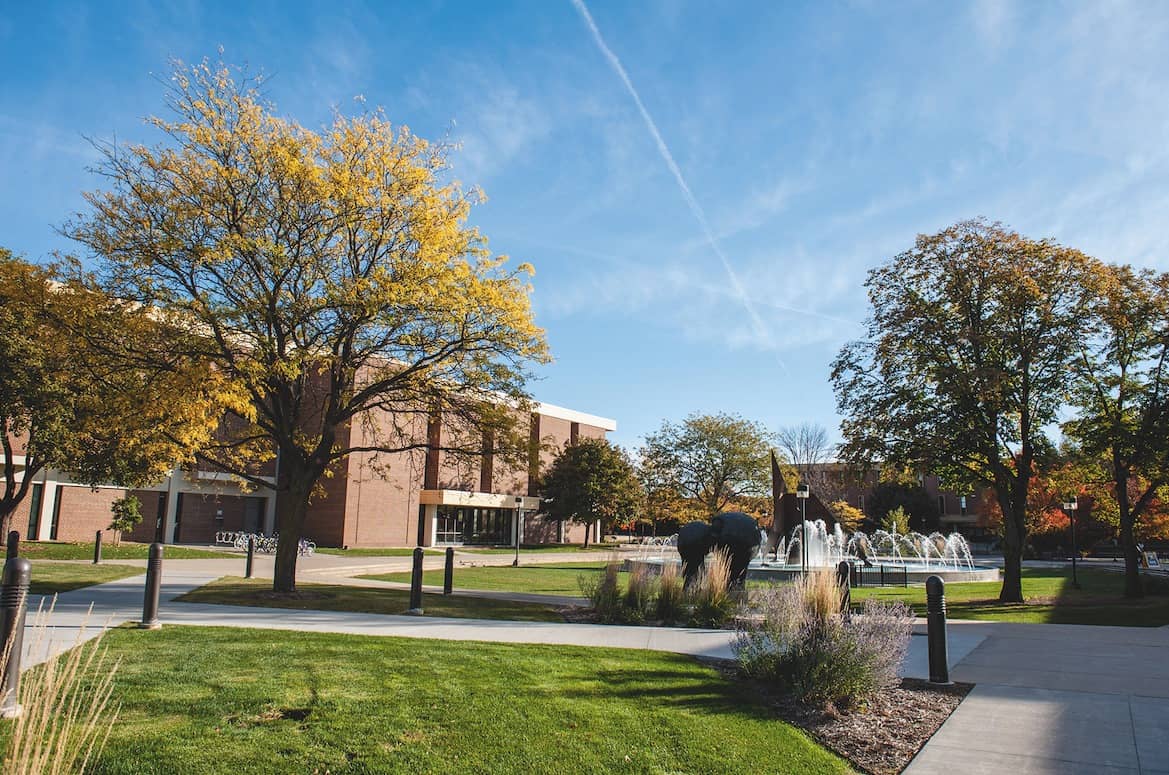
1064 264 1169 597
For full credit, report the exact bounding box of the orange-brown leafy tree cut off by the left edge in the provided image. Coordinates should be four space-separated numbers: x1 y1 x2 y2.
0 248 224 538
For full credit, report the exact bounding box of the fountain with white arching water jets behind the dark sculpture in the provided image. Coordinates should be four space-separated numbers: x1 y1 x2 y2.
630 519 998 583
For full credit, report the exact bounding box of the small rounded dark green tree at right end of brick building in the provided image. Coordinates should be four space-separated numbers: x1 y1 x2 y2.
540 438 644 547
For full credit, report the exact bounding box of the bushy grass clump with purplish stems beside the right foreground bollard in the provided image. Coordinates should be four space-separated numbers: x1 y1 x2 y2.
735 569 913 708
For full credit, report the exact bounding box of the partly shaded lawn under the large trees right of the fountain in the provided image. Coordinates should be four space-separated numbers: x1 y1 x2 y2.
852 568 1169 627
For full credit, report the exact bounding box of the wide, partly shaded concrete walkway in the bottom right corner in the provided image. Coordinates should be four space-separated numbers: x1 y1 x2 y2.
905 622 1169 775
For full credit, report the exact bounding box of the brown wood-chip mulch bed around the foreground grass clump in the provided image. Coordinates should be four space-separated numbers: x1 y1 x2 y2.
704 659 974 775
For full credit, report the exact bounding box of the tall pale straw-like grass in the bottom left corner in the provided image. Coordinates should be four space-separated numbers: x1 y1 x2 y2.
0 606 118 775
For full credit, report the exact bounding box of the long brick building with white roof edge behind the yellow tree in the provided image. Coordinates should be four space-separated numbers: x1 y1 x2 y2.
4 403 617 547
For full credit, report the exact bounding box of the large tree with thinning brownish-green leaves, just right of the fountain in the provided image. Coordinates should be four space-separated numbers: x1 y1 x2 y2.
832 220 1091 602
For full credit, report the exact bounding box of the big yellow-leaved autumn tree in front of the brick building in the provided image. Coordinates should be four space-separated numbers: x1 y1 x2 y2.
64 61 547 591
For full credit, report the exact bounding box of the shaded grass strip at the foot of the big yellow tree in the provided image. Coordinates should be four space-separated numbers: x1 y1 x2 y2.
179 576 563 622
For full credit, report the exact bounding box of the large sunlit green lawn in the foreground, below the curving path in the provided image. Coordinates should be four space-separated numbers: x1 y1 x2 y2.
9 627 850 775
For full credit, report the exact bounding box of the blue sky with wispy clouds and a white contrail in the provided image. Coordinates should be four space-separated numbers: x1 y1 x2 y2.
0 0 1169 445
